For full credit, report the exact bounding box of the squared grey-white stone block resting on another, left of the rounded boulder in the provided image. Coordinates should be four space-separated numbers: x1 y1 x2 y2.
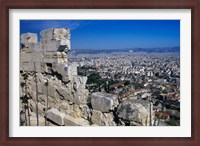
91 92 119 112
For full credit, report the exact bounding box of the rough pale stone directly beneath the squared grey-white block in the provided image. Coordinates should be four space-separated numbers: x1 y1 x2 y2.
91 110 116 126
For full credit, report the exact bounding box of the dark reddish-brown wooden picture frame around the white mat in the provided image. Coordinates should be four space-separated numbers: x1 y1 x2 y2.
0 0 200 146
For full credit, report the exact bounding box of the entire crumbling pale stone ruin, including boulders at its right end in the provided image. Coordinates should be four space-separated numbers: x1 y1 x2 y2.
20 28 153 126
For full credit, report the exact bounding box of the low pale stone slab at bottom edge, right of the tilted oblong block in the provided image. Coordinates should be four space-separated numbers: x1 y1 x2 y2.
64 115 90 126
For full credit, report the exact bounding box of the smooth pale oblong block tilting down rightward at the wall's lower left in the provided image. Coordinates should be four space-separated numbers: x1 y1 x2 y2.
45 108 65 126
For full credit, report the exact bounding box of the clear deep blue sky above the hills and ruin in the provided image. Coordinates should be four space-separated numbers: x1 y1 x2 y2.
20 20 180 49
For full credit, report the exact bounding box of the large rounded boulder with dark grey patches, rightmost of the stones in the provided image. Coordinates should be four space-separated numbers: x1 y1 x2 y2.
117 99 153 126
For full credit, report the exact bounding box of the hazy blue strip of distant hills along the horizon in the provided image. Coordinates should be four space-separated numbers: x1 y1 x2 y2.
71 47 180 54
